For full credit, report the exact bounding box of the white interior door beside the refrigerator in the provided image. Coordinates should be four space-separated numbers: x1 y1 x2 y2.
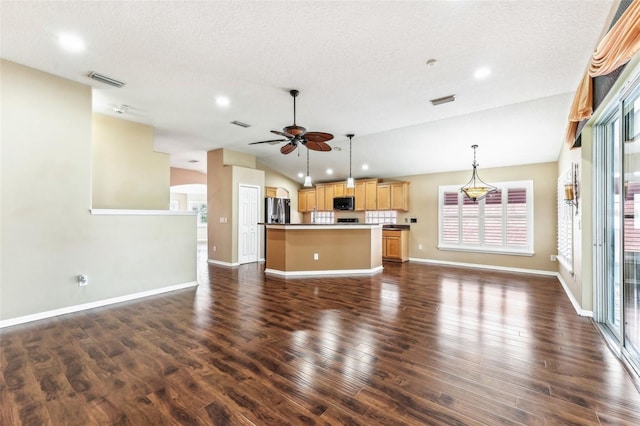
238 185 260 263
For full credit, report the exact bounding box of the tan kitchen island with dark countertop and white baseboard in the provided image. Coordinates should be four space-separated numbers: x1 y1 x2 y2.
265 224 382 276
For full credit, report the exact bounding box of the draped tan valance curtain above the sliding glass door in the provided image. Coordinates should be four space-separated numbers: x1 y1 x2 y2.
566 0 640 147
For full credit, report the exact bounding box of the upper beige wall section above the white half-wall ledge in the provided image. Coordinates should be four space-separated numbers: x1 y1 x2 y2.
92 114 170 210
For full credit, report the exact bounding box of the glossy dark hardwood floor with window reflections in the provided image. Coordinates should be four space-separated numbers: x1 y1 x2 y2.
0 255 640 425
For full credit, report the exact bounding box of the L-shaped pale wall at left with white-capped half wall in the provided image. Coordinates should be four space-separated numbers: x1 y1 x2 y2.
0 60 196 321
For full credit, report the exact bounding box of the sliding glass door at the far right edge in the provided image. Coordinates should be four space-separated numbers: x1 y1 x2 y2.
594 78 640 371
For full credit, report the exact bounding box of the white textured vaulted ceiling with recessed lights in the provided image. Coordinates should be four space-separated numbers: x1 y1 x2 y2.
0 0 614 185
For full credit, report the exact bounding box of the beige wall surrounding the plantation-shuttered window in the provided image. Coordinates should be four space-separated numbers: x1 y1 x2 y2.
394 163 558 272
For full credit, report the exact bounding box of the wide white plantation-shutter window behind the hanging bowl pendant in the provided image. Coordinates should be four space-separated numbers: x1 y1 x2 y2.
438 181 533 255
